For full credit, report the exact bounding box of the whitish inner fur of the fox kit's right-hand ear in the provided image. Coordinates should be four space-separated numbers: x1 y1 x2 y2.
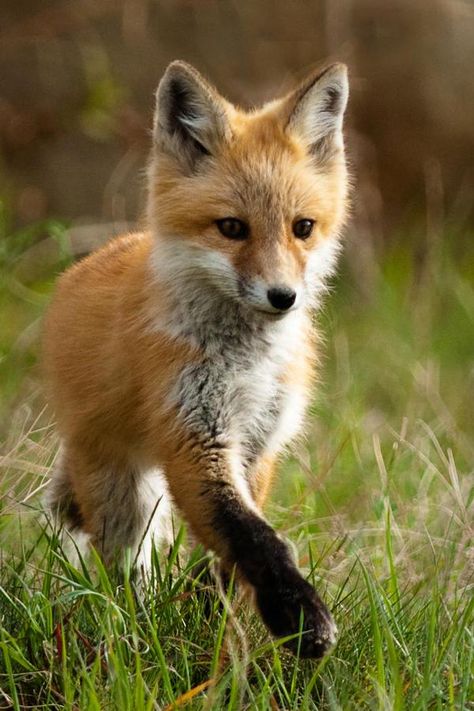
288 64 349 147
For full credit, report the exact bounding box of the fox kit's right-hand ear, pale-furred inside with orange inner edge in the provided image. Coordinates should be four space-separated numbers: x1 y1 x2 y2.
284 64 349 162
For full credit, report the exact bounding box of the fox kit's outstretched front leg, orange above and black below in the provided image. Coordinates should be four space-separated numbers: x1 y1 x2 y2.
161 437 336 657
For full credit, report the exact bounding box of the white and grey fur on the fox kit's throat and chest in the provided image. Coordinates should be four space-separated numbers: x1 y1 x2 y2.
168 311 312 470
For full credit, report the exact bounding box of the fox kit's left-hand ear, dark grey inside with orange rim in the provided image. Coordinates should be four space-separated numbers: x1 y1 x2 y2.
154 61 231 169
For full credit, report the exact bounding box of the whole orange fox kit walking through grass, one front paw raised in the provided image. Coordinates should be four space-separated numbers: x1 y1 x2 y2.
44 62 348 657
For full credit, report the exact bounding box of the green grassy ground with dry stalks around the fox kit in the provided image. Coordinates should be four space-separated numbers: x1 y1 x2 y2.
0 224 474 711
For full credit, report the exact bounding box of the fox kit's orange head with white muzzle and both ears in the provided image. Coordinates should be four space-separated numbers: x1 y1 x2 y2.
149 61 348 318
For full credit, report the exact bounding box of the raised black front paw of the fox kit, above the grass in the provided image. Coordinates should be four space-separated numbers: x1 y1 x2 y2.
256 569 337 658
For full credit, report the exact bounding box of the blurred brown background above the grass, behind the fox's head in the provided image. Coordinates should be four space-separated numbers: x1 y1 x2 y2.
0 0 474 242
